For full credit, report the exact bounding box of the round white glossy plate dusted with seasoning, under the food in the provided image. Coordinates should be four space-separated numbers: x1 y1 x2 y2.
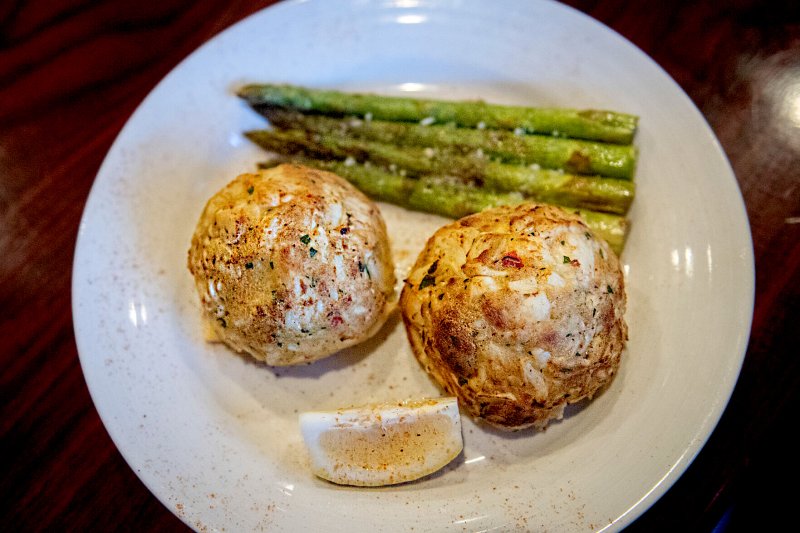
73 0 753 531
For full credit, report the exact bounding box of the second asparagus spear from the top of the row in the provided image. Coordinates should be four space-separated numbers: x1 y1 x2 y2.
259 108 636 180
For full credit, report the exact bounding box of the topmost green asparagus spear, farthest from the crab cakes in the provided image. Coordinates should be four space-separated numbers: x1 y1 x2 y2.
238 84 638 144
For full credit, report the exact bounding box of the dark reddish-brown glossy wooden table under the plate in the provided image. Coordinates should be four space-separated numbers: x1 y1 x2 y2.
0 0 800 531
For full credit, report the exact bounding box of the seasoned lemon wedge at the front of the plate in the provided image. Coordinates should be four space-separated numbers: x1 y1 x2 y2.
300 398 464 487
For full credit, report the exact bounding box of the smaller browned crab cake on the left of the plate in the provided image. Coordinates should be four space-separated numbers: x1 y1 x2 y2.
188 165 395 365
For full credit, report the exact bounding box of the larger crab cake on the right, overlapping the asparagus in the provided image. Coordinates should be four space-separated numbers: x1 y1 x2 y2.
400 204 627 430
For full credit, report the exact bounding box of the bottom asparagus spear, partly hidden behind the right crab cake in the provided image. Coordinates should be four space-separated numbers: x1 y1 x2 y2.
259 155 628 254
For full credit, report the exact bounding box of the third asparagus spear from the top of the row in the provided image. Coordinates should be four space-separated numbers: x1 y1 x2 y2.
245 130 634 215
